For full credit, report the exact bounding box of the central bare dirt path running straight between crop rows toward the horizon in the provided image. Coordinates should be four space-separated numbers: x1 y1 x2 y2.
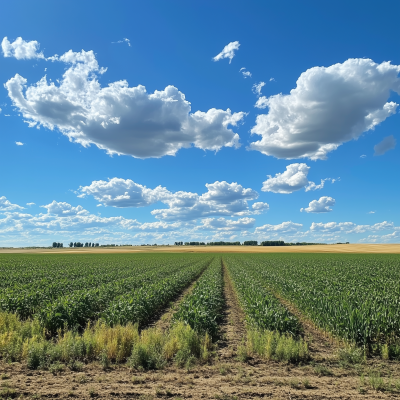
218 261 246 361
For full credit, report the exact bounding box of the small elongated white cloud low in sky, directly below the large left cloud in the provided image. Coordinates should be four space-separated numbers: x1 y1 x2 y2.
79 178 171 207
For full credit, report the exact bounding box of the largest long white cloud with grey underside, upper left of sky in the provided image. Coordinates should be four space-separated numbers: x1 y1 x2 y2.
5 41 245 158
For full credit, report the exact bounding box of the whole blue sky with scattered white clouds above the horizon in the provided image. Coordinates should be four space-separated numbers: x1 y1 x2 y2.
0 0 400 247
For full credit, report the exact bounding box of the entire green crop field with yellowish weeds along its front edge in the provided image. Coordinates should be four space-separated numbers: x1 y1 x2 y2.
0 252 400 398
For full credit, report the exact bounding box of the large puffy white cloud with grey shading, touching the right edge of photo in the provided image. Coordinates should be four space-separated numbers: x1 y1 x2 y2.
250 59 400 160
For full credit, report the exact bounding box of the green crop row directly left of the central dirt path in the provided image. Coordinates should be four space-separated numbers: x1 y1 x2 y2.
173 257 224 339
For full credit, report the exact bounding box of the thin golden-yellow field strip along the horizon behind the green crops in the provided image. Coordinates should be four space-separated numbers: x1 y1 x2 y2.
0 244 400 254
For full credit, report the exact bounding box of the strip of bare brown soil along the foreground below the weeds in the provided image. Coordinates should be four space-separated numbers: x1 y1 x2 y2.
0 357 400 400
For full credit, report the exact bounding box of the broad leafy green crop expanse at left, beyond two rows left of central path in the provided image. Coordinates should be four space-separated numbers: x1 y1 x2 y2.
0 254 210 334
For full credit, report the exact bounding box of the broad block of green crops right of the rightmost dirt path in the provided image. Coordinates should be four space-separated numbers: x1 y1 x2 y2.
231 255 400 348
